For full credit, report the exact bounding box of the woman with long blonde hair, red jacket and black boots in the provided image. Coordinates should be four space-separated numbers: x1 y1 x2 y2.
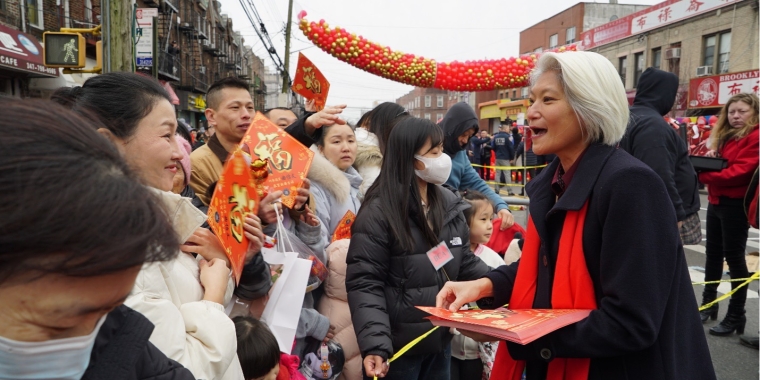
699 94 760 335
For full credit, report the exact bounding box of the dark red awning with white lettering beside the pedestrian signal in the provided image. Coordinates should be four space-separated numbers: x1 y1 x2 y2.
0 25 58 78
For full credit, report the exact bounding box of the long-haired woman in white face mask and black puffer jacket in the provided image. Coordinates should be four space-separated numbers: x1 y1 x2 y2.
346 117 488 380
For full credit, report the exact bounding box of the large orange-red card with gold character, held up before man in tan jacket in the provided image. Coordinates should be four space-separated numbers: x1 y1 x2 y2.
240 112 314 208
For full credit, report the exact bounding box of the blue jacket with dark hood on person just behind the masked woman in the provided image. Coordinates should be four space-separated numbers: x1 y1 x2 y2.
438 102 507 212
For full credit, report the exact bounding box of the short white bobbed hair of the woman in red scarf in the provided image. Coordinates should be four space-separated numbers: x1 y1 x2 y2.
530 51 629 145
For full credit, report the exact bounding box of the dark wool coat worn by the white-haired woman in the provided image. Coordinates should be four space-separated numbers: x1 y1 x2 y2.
480 144 715 380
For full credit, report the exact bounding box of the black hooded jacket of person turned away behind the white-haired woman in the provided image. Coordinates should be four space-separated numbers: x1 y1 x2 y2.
620 67 699 221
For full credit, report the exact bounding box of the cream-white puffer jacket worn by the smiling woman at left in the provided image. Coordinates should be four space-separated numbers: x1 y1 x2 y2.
124 190 242 380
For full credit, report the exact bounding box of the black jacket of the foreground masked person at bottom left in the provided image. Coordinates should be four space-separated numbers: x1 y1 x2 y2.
82 305 195 380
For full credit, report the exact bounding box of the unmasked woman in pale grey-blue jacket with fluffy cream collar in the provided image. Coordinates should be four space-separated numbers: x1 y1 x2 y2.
309 124 362 247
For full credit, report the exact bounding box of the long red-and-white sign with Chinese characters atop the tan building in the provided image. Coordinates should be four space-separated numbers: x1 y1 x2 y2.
581 0 741 50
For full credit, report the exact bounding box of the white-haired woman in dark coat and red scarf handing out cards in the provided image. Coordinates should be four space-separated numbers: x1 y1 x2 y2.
436 52 715 380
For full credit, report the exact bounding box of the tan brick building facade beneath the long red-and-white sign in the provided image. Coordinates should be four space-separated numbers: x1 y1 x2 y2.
590 0 760 117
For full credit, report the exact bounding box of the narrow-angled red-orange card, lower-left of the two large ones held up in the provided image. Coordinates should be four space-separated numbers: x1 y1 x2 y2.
208 150 259 282
